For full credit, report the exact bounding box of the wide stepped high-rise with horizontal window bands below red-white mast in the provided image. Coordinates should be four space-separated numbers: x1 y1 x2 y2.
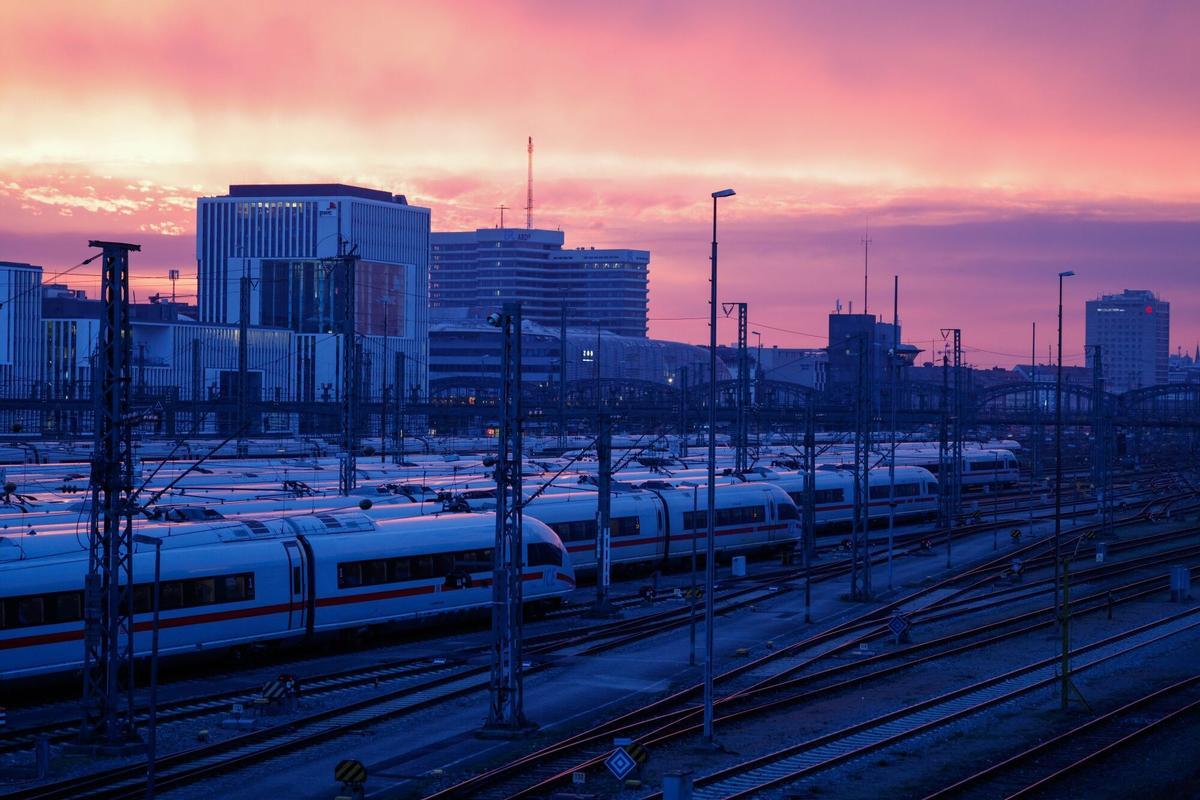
430 228 650 337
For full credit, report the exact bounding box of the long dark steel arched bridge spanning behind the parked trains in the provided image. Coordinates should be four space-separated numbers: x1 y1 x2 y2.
7 378 1200 438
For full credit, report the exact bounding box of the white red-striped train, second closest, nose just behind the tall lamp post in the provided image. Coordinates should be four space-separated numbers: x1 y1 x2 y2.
524 483 800 570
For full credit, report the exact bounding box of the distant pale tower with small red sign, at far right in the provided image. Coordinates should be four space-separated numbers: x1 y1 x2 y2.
1086 289 1171 393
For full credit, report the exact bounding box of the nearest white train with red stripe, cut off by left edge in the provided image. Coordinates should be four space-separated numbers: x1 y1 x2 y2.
0 513 575 681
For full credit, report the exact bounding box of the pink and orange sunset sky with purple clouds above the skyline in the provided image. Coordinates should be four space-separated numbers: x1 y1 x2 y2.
0 0 1200 366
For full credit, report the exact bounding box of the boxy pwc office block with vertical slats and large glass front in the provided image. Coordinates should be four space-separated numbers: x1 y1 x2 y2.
197 184 430 397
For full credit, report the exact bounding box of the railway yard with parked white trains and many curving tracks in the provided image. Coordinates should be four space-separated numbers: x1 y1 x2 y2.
0 437 1200 800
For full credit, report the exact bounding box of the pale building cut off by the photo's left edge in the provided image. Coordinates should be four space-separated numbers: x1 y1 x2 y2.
0 261 42 398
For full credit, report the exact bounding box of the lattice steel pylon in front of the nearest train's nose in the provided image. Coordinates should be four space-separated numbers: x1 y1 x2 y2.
484 302 534 735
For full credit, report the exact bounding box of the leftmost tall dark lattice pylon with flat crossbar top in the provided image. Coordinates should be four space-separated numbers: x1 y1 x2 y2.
78 241 142 752
